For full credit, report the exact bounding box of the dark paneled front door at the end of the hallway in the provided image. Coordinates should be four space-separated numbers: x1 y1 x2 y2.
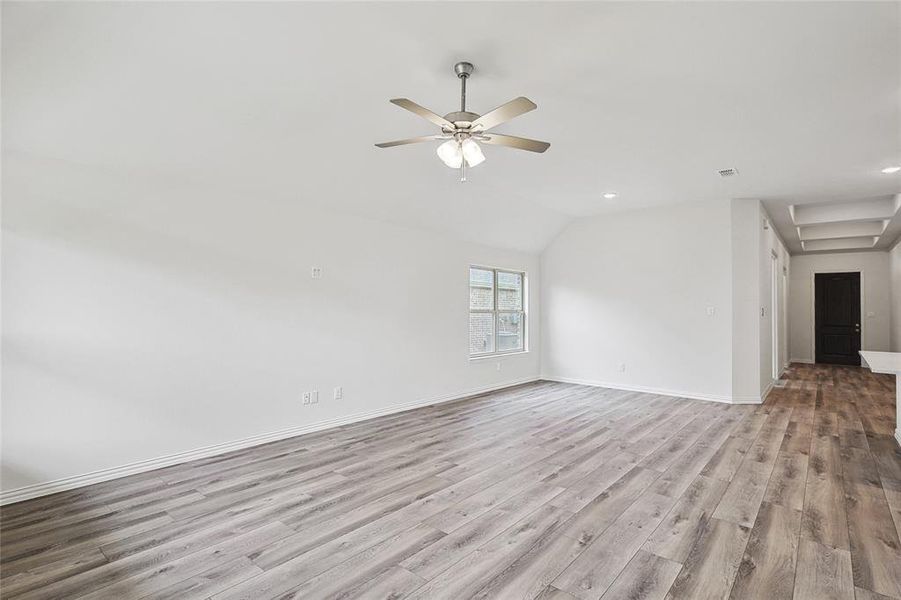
814 273 860 365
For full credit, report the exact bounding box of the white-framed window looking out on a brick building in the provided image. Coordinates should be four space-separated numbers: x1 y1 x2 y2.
469 267 526 357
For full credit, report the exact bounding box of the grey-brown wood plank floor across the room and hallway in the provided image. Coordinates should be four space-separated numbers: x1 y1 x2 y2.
0 365 901 600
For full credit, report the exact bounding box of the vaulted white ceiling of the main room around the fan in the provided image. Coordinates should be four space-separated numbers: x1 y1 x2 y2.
2 2 901 252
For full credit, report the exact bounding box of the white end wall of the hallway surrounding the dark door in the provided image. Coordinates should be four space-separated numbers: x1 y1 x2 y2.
789 252 892 361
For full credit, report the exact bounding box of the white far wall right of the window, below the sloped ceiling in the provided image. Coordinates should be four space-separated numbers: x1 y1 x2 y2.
541 201 732 399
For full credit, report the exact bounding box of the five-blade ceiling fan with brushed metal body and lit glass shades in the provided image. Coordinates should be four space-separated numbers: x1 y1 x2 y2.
376 62 551 181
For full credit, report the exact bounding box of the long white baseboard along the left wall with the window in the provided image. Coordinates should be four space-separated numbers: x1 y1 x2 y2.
0 377 540 506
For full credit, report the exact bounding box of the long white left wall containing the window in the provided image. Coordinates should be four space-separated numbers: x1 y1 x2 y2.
2 157 540 491
